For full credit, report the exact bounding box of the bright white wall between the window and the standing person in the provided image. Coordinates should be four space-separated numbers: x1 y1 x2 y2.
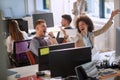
50 0 76 25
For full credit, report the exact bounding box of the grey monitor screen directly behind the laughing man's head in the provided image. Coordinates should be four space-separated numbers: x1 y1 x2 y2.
32 13 54 28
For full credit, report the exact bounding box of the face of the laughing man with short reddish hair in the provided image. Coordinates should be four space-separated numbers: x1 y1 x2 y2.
36 23 47 37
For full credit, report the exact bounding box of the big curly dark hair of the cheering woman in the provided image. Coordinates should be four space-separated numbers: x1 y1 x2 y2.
76 15 94 33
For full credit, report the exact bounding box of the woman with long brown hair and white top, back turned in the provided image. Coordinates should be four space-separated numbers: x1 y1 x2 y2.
6 20 28 53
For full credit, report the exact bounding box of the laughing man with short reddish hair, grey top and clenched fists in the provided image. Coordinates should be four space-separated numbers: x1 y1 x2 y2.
30 19 57 56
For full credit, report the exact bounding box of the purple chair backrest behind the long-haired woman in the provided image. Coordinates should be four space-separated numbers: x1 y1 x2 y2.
13 40 31 66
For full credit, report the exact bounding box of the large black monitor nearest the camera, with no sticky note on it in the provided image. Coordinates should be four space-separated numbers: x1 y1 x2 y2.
49 47 91 78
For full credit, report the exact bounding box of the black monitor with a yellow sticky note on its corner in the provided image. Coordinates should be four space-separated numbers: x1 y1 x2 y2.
38 43 74 71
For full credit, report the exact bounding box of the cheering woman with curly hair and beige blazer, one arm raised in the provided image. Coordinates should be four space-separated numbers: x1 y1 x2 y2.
64 9 120 48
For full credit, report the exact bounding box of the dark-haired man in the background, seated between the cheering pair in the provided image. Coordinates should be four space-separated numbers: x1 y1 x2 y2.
57 14 72 43
